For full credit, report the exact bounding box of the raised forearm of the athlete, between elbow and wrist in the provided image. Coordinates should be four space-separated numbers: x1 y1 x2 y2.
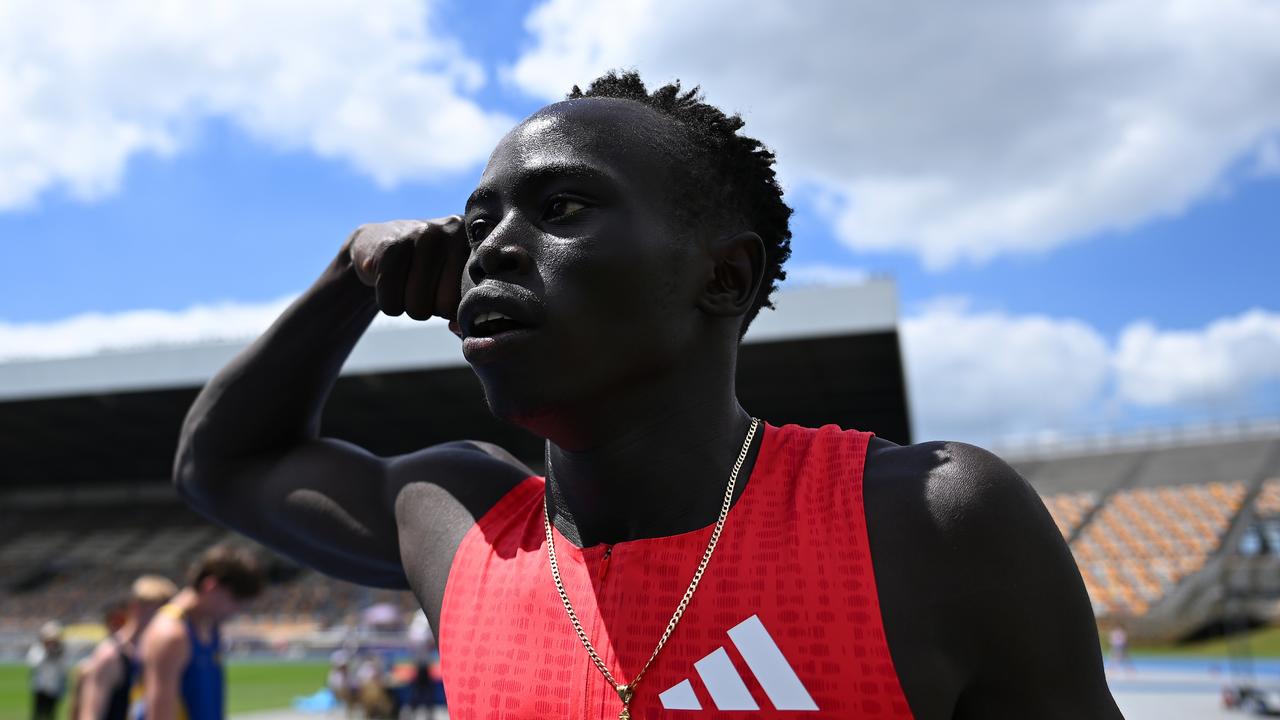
175 251 378 489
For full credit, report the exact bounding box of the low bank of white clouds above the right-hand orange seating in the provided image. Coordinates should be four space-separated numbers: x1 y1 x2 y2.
901 300 1280 442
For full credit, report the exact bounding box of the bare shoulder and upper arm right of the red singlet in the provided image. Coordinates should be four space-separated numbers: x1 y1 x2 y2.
864 441 1119 717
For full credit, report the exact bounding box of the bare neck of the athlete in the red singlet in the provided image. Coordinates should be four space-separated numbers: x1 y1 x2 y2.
547 378 764 547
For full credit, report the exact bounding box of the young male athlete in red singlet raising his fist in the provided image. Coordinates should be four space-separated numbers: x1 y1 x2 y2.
175 74 1120 720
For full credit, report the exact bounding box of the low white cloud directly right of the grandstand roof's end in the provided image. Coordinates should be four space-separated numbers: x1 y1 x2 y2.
901 301 1110 441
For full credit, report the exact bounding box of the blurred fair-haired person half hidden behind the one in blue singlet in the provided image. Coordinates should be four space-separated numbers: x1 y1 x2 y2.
72 575 178 720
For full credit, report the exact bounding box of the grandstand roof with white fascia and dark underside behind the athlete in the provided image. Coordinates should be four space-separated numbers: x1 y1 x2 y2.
0 279 910 487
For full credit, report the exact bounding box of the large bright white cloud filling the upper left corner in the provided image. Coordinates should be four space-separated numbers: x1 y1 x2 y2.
0 0 512 210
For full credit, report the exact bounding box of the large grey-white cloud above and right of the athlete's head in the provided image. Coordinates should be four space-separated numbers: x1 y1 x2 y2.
509 0 1280 268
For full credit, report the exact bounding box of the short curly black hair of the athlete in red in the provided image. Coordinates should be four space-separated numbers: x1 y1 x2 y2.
568 70 792 337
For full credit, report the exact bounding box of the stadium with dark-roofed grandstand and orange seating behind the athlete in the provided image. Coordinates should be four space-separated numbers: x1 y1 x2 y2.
0 279 1280 707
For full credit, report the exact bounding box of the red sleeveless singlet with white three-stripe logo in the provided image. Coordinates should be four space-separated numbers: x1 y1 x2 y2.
440 425 911 720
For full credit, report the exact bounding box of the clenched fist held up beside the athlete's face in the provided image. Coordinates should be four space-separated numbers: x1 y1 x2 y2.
347 215 468 320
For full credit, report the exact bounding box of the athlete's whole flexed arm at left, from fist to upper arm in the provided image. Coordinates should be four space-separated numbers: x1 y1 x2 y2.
174 217 518 588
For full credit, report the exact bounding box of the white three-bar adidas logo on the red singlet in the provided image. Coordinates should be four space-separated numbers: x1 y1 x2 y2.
658 615 818 711
